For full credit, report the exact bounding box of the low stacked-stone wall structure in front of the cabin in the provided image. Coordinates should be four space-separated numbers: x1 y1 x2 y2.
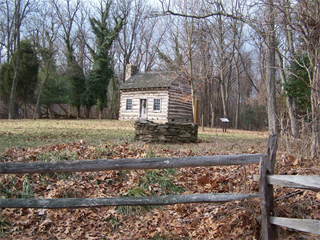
134 120 198 143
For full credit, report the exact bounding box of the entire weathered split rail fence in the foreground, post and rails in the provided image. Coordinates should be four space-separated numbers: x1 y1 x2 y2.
0 135 320 239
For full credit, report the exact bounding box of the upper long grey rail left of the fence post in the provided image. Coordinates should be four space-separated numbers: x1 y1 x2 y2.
0 154 268 174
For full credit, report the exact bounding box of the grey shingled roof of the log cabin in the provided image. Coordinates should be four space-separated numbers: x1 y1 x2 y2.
120 72 178 90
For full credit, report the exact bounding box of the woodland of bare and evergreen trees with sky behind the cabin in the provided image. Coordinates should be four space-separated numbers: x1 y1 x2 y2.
0 0 320 154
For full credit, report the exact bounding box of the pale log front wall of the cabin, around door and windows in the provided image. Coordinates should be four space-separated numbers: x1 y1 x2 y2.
119 89 169 122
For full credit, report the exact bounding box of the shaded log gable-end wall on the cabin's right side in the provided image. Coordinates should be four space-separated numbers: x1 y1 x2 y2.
168 79 192 123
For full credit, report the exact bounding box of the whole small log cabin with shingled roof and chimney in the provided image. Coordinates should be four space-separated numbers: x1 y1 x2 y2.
119 64 192 123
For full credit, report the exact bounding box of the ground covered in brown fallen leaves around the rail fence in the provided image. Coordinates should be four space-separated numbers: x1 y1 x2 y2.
0 121 320 239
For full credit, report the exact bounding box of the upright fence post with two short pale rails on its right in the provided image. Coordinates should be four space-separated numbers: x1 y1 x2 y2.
254 139 320 239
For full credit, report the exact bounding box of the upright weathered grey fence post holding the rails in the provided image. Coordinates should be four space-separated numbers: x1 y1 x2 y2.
259 134 278 240
